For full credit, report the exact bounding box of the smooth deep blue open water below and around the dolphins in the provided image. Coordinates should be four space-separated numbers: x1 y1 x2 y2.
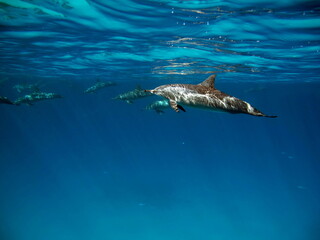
0 79 320 240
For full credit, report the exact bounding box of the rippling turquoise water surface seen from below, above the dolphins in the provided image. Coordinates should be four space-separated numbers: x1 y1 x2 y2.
0 0 320 80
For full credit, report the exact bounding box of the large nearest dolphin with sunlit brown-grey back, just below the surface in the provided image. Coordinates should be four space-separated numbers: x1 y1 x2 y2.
145 75 276 118
